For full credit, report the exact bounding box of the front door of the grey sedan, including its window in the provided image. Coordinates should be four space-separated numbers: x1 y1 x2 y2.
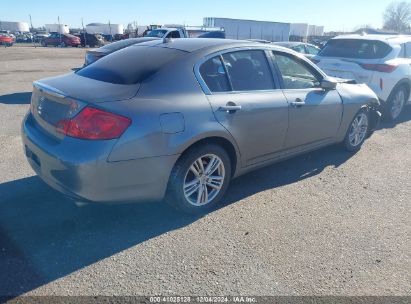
273 52 343 149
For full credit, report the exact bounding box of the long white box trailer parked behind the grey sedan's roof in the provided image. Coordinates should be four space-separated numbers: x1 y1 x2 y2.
203 17 290 41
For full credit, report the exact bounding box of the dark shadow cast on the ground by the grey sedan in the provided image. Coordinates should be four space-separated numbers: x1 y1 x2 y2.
0 146 352 297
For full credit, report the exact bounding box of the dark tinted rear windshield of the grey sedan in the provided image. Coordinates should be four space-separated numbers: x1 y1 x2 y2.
77 45 185 84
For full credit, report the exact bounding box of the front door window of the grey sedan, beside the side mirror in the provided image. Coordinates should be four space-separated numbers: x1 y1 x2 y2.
275 53 320 89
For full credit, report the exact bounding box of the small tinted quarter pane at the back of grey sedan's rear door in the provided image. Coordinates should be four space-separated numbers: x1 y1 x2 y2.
200 56 230 92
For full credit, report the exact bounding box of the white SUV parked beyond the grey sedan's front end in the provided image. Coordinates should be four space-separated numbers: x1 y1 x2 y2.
312 35 411 121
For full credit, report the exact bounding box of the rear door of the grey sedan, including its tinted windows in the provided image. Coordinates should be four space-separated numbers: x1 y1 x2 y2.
199 49 288 166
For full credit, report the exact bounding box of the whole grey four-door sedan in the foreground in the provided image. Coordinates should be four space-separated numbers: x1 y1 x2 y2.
22 39 380 213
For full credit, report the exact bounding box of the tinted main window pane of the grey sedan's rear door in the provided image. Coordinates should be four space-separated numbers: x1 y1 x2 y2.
223 50 275 91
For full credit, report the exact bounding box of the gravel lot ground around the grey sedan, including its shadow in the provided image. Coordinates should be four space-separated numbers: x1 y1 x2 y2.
0 47 411 296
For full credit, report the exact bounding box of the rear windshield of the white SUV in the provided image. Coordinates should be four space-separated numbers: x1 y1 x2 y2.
319 39 392 59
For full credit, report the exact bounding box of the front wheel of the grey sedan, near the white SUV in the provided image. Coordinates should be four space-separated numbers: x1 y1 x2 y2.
344 108 370 152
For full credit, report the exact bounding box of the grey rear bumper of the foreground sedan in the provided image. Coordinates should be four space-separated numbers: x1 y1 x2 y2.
22 115 178 203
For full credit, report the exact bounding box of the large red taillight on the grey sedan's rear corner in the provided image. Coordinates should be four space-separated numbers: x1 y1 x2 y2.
56 107 131 140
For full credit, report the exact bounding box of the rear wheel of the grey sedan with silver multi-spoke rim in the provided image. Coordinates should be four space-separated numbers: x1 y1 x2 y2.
166 144 231 214
